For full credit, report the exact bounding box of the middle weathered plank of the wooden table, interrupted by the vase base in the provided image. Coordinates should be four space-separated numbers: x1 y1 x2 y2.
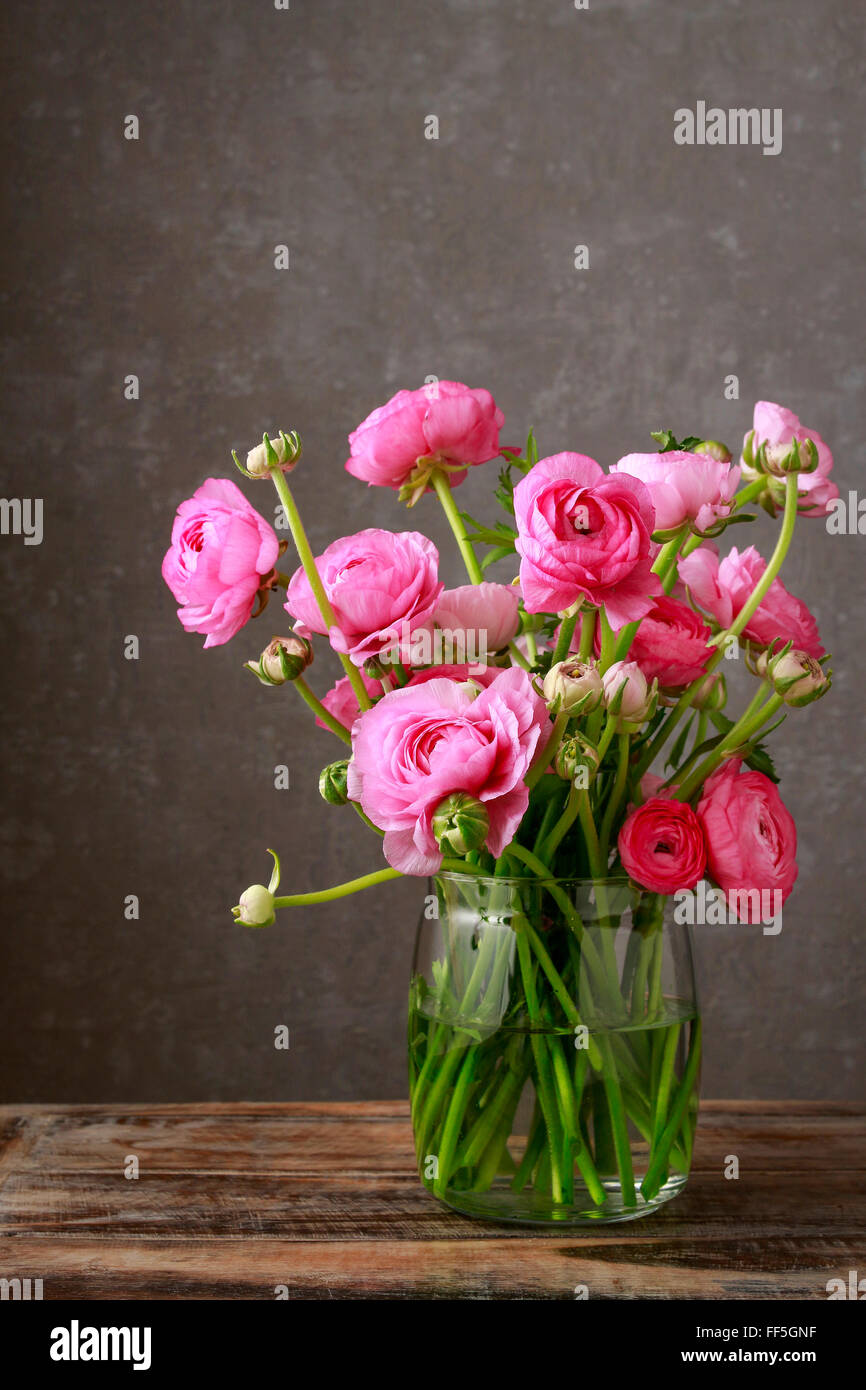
0 1172 863 1243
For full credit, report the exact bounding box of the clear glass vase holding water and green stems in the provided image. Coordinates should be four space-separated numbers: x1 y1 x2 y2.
409 873 701 1226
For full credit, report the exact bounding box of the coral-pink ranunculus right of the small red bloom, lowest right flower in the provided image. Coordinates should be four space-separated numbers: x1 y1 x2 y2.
698 760 796 922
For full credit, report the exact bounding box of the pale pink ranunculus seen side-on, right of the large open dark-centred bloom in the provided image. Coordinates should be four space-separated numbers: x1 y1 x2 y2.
610 449 740 531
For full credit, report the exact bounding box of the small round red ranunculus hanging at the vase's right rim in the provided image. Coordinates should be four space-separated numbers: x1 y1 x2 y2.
617 796 706 894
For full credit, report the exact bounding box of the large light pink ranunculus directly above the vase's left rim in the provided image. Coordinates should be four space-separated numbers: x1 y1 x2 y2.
349 667 550 874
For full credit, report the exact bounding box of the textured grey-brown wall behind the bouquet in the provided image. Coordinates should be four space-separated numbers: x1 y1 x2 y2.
0 0 866 1101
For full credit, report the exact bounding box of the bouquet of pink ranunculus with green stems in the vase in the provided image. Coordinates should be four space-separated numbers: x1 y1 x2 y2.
163 381 837 1208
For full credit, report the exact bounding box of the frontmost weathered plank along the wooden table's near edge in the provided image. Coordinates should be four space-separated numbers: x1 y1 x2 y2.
0 1234 851 1300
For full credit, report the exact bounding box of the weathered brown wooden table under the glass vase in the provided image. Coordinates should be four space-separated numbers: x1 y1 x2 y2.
0 1101 866 1300
